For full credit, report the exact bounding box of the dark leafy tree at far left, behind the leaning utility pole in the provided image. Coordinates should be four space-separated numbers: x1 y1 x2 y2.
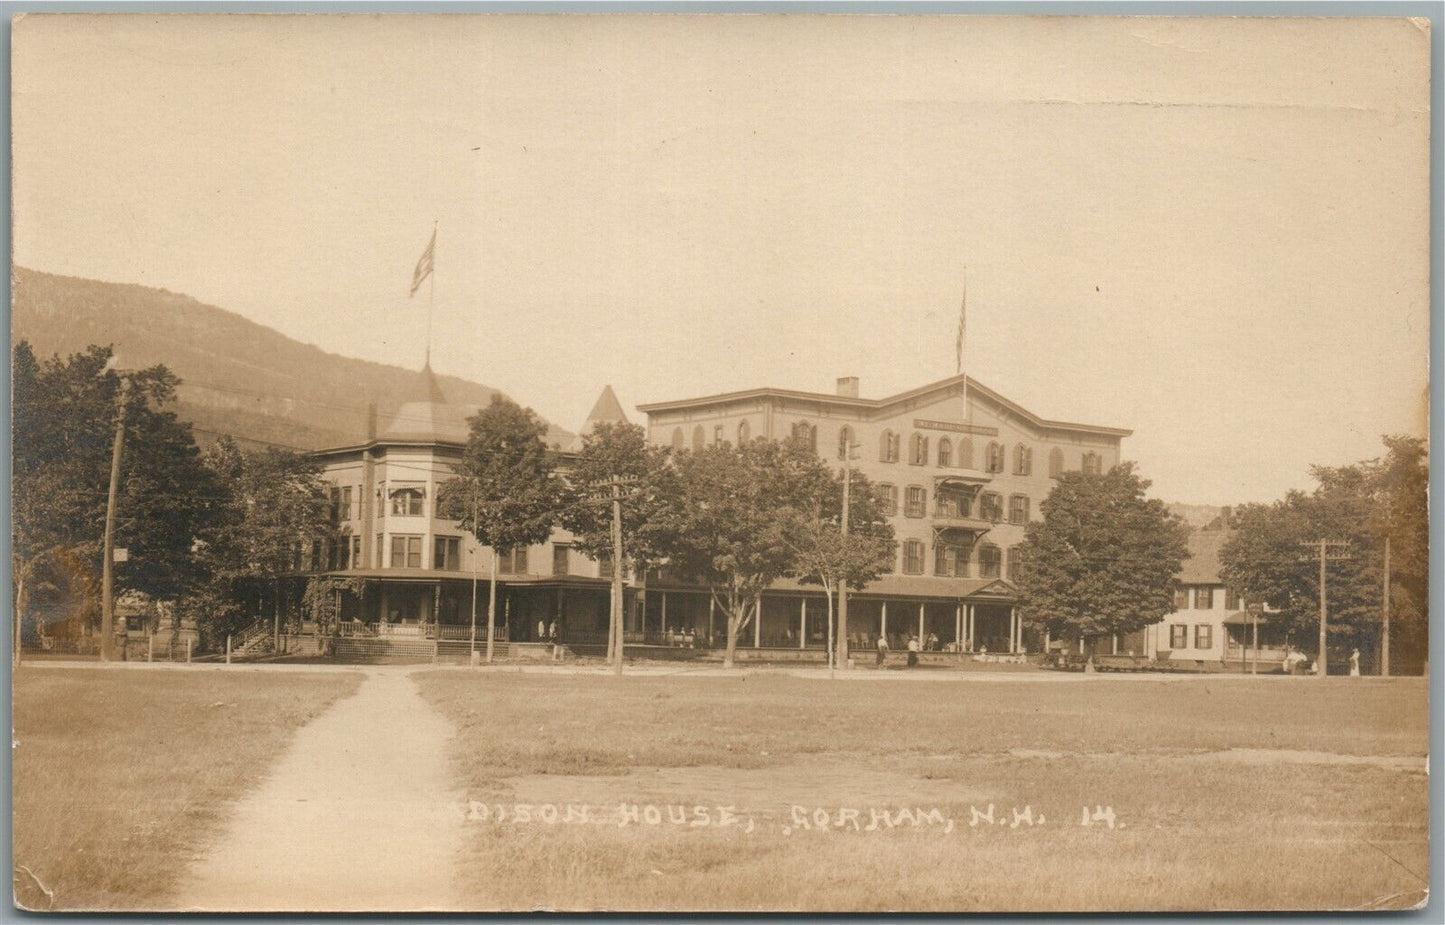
12 341 224 650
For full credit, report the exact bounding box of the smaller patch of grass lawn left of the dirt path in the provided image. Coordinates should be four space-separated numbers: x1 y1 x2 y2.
13 666 361 911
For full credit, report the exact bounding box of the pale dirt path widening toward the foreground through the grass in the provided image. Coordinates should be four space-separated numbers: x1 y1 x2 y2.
179 668 462 912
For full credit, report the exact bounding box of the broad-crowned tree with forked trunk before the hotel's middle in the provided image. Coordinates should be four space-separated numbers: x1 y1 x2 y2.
655 438 835 668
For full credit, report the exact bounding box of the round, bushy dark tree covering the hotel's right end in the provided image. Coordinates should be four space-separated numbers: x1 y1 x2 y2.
1016 463 1188 647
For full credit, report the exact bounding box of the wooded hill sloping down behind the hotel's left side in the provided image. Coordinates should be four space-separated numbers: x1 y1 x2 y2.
12 267 571 449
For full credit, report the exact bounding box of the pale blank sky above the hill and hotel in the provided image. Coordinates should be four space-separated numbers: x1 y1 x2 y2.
13 14 1429 504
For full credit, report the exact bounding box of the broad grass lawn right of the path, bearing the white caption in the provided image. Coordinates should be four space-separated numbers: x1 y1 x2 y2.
418 669 1428 911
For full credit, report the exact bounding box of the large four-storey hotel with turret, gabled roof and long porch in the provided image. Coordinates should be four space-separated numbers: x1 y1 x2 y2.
302 369 1130 655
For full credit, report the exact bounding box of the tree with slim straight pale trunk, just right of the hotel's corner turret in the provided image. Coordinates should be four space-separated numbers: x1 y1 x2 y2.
436 395 561 662
